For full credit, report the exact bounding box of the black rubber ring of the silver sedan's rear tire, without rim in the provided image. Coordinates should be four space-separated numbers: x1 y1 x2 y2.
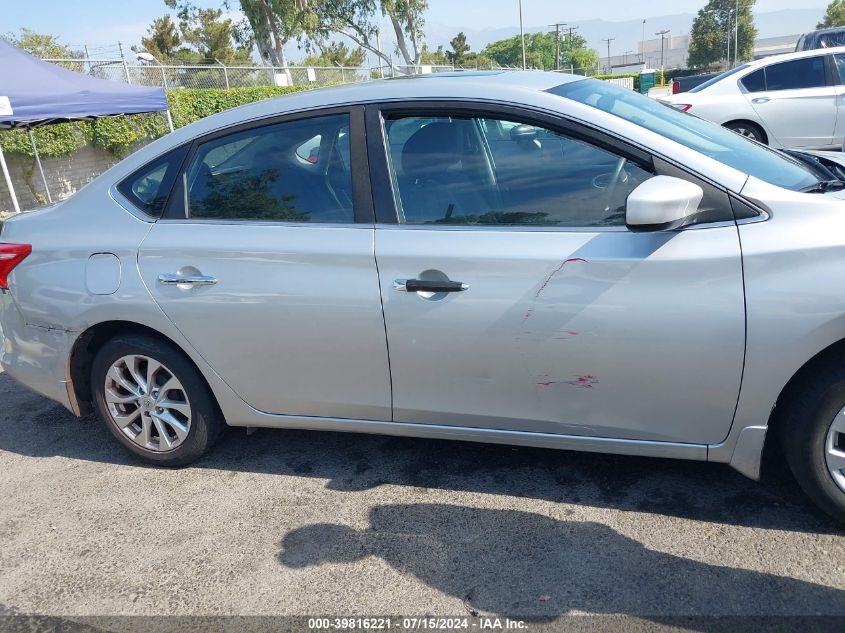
91 335 224 466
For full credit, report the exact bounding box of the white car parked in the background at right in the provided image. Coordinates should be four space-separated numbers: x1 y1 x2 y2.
660 47 845 149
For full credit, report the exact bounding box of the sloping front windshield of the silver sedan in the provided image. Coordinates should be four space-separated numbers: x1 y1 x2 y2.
548 79 819 191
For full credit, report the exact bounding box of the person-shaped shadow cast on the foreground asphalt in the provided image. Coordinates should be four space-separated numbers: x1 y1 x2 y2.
278 504 845 628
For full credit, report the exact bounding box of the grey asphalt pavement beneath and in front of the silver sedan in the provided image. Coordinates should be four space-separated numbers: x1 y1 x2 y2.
0 366 845 628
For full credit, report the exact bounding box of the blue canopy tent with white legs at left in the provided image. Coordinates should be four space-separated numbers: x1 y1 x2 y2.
0 38 173 212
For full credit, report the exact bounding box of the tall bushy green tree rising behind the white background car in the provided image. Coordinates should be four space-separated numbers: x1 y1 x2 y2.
687 0 757 67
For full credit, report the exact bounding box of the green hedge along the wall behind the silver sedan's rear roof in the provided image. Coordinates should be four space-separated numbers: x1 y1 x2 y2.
0 86 306 157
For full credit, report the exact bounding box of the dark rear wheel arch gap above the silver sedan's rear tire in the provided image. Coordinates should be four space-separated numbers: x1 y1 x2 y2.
68 320 220 415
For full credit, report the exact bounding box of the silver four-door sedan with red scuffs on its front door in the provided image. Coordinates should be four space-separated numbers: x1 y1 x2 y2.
0 72 845 519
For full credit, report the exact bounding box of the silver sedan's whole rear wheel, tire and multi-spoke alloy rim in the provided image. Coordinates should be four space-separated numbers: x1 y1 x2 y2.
91 334 226 466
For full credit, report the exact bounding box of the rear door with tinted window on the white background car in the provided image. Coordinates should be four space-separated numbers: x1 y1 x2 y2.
745 55 837 148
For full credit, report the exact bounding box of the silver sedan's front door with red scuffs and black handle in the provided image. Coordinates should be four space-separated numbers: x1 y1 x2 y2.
368 105 745 444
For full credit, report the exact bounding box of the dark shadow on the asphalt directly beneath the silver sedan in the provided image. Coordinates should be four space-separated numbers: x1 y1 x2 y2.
0 373 842 533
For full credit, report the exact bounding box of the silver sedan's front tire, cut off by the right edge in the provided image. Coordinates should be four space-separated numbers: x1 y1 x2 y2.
776 358 845 523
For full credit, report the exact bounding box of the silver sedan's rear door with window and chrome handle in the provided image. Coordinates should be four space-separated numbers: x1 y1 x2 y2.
138 109 391 420
